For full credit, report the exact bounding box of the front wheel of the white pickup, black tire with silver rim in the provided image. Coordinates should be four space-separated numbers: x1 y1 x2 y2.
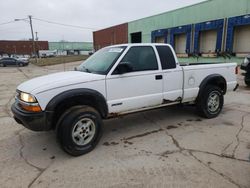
57 106 102 156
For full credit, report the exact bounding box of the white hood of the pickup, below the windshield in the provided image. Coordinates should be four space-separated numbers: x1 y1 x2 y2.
17 71 105 94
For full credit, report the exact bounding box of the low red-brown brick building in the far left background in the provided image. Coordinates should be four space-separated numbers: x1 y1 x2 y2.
0 40 49 55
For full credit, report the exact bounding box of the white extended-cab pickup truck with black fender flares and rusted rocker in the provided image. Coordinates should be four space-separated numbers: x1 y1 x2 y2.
12 44 238 156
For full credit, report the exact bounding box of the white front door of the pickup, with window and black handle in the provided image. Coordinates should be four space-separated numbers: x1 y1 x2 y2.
106 46 163 113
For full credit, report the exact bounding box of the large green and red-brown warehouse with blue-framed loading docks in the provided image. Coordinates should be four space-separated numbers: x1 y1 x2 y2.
93 0 250 62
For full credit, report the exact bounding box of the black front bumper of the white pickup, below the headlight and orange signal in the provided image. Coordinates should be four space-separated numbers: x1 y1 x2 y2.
11 102 52 131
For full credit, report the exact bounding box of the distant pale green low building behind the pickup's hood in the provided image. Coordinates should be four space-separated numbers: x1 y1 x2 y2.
49 41 93 55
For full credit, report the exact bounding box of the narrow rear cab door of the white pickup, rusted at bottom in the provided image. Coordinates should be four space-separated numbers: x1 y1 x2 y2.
156 45 183 103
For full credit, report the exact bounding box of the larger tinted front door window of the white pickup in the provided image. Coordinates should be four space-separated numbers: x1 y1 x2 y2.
121 46 158 72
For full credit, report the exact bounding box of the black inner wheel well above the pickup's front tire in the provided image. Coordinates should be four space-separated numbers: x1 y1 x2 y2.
52 95 107 129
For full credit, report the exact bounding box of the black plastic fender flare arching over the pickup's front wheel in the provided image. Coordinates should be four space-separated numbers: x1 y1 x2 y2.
45 88 108 118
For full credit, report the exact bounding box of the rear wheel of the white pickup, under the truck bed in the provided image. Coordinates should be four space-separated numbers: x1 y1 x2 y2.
196 85 224 119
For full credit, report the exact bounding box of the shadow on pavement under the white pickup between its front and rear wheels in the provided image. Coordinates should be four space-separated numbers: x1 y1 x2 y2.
103 105 198 141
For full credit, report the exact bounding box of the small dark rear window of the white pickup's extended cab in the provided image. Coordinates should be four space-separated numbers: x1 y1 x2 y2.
156 46 176 70
